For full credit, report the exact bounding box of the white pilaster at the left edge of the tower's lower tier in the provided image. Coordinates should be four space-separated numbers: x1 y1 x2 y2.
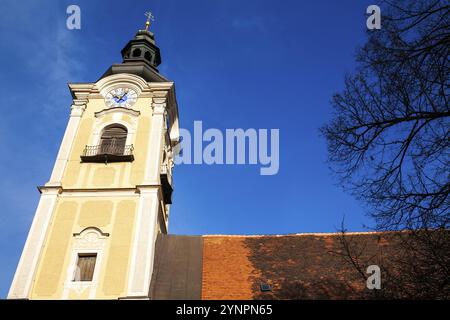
8 187 61 299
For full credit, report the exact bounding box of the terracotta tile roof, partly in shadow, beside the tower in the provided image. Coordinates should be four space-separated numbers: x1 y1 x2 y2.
152 232 398 299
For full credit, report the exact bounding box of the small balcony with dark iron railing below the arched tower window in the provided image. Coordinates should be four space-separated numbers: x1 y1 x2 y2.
81 144 134 163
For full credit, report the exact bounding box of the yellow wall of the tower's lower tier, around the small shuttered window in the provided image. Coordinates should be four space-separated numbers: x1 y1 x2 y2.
31 196 138 299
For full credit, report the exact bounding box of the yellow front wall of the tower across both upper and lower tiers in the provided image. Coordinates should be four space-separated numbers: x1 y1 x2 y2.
30 98 152 299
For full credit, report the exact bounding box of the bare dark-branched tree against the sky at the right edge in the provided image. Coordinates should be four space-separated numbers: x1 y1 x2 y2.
321 0 450 298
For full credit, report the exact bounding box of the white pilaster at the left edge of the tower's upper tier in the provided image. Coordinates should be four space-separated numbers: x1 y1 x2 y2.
46 100 86 186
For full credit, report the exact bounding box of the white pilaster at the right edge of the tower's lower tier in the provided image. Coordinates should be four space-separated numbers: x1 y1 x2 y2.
126 187 160 299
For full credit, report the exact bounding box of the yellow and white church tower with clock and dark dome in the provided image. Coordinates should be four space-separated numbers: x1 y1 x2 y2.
8 20 179 299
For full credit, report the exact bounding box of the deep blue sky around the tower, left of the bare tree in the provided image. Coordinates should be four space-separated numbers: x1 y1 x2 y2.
0 0 373 297
